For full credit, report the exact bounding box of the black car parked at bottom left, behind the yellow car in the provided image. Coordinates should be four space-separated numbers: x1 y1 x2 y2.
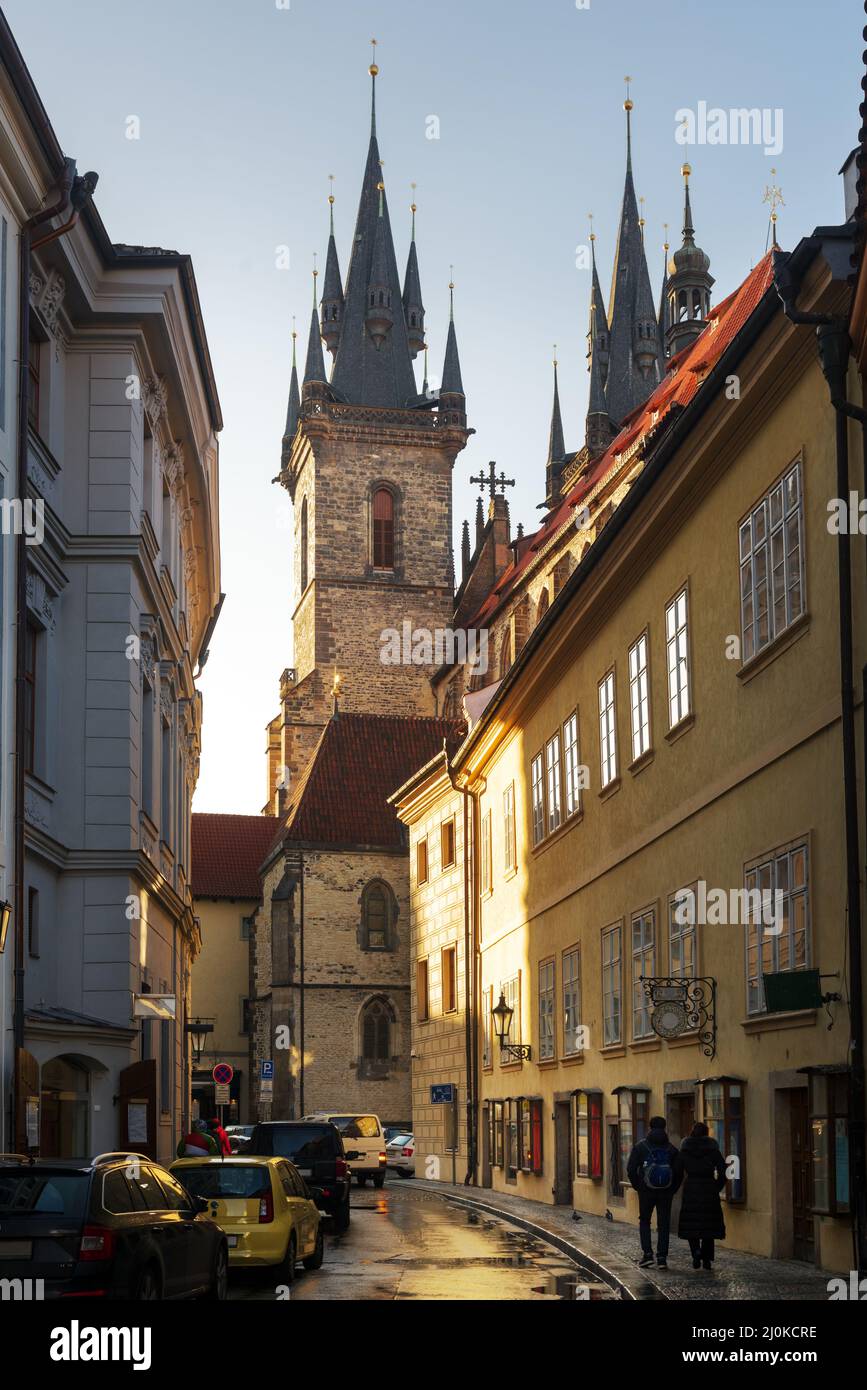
0 1154 229 1298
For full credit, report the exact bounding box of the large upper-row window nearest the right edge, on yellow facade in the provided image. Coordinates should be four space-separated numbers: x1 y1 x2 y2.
738 461 804 662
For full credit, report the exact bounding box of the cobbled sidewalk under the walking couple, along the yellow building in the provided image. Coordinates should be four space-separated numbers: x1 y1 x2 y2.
413 1179 834 1302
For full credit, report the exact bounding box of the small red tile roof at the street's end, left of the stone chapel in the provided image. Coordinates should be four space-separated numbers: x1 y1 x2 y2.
190 812 276 898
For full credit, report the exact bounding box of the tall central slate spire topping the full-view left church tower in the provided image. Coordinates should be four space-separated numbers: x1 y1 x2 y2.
331 54 417 407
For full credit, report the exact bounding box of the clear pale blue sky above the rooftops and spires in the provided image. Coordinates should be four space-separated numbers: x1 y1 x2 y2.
4 0 864 812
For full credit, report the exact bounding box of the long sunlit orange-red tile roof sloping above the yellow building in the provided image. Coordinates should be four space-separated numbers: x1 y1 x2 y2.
465 252 774 628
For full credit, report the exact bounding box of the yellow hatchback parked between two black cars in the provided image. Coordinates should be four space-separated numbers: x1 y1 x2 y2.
171 1154 322 1284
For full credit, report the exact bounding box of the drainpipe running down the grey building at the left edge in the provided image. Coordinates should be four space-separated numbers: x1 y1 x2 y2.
11 158 99 1134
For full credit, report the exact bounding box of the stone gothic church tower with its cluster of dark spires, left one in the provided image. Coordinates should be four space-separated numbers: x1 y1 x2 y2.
265 54 471 813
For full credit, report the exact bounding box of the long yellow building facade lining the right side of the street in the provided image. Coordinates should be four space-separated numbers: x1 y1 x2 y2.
400 229 867 1269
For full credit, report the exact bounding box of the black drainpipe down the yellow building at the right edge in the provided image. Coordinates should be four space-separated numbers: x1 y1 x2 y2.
774 257 867 1276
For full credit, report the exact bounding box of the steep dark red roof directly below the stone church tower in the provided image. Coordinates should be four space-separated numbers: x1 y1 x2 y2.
271 713 460 849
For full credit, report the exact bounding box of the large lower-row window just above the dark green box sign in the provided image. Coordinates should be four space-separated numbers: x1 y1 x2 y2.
743 841 810 1013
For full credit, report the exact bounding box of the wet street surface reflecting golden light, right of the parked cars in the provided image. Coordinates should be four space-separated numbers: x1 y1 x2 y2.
229 1180 617 1302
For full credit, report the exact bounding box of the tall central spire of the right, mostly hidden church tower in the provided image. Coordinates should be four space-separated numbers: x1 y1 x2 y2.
606 88 660 425
